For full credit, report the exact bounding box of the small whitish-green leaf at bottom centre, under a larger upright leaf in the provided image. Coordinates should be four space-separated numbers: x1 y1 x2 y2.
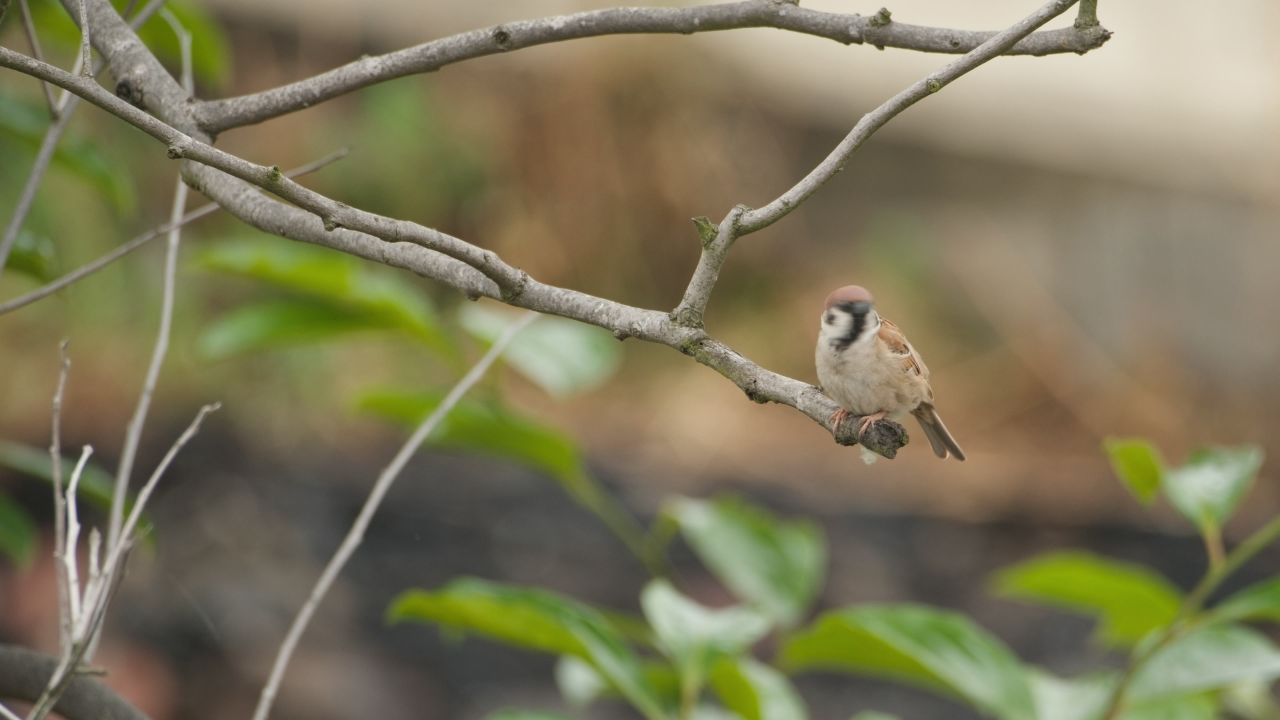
640 580 769 688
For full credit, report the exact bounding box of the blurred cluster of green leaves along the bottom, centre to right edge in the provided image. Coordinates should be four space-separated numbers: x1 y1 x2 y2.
389 441 1280 720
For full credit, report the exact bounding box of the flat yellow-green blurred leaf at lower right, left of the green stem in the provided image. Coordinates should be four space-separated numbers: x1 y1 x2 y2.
993 552 1183 648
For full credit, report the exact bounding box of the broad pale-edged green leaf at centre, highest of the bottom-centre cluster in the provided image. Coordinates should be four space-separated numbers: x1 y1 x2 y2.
669 498 827 625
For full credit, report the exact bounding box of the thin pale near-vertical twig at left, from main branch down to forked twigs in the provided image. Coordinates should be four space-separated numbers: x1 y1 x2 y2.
106 178 187 546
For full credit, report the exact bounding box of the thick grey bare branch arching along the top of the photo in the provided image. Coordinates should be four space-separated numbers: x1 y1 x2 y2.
196 0 1110 135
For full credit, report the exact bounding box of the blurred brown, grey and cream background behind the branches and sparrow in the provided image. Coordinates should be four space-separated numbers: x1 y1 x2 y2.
0 0 1280 719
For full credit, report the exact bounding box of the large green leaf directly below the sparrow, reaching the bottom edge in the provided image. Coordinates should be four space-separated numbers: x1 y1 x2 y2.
782 605 1036 720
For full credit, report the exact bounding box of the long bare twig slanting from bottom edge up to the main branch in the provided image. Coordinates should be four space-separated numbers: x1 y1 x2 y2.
252 313 538 720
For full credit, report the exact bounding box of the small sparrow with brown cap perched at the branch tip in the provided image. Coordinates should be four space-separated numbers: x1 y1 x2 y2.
814 284 964 460
